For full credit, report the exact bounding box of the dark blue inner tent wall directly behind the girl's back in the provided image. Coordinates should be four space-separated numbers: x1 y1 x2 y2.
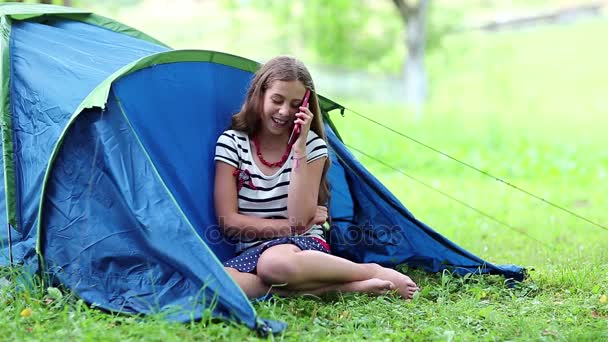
109 62 251 261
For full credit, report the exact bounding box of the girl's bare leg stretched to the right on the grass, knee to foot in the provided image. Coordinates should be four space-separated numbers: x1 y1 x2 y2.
257 245 418 299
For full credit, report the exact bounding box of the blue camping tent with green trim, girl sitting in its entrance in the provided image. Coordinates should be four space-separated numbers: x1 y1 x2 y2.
0 4 524 332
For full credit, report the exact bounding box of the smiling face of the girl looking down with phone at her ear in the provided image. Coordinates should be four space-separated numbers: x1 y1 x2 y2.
261 81 306 135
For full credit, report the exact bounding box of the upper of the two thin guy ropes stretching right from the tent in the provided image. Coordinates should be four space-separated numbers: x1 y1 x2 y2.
345 108 608 231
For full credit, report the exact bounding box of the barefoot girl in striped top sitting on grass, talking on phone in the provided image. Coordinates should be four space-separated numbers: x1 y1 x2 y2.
214 56 418 299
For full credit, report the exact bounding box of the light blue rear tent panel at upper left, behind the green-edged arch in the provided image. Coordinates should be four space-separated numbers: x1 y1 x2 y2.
2 12 167 259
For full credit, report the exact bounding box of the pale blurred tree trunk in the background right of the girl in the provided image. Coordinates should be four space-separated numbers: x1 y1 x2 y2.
393 0 428 116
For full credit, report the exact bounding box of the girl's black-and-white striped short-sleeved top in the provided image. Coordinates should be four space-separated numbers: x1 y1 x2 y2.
214 130 327 253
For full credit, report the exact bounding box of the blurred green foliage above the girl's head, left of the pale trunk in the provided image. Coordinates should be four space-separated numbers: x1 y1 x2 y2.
226 0 396 71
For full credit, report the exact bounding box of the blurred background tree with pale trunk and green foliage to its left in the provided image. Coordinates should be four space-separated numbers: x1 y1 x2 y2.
235 0 442 113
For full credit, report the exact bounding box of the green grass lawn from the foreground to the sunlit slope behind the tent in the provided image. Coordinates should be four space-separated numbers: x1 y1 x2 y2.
0 3 608 341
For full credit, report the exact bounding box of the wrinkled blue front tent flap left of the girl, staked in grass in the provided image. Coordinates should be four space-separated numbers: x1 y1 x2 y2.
41 98 256 327
